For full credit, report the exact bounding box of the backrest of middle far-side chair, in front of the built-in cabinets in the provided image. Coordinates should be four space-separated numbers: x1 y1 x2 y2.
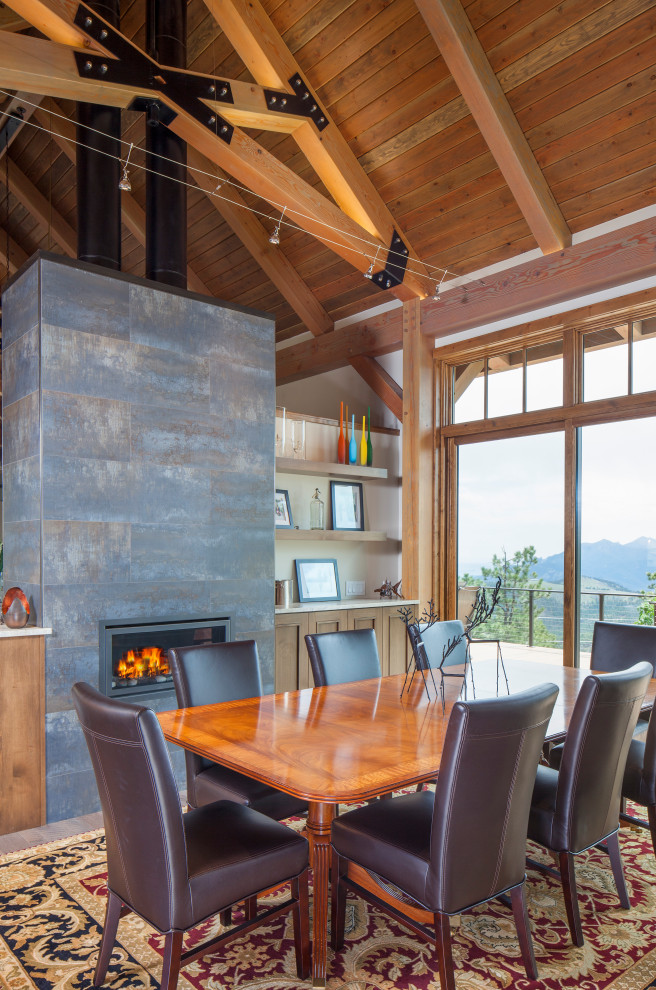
305 629 381 687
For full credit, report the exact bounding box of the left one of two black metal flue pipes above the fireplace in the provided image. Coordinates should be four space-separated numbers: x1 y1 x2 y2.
76 0 122 271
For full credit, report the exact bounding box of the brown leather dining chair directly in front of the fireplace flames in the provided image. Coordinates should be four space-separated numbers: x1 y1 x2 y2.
168 639 307 821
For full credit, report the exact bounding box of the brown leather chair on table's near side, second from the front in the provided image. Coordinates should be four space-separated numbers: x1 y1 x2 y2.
528 663 653 946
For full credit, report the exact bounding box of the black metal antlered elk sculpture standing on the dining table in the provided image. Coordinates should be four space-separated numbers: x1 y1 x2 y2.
398 578 508 709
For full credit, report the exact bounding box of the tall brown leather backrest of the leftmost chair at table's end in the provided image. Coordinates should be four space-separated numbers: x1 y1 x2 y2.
72 682 191 931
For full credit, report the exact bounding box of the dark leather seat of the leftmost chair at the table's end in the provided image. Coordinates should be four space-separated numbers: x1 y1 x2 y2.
180 800 308 928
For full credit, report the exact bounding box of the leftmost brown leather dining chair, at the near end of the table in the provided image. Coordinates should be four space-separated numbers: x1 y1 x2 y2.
72 683 310 990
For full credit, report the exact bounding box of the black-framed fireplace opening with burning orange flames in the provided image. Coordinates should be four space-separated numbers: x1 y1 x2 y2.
98 616 230 701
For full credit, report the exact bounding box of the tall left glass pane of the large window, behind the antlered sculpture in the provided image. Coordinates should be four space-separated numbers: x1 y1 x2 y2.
458 432 564 663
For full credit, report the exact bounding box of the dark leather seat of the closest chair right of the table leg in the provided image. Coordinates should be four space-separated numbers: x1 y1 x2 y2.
332 791 435 910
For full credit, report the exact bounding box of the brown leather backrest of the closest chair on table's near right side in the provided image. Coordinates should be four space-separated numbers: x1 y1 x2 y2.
426 684 558 912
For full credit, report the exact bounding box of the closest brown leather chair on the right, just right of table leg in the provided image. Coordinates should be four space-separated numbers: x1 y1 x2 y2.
332 684 558 990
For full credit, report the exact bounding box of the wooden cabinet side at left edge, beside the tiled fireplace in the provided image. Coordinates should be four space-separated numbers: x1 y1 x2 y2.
0 633 46 834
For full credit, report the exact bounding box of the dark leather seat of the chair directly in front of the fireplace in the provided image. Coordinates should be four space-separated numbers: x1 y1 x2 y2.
192 763 307 820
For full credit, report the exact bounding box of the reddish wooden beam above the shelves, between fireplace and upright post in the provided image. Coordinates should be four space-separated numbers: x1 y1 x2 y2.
276 307 402 385
